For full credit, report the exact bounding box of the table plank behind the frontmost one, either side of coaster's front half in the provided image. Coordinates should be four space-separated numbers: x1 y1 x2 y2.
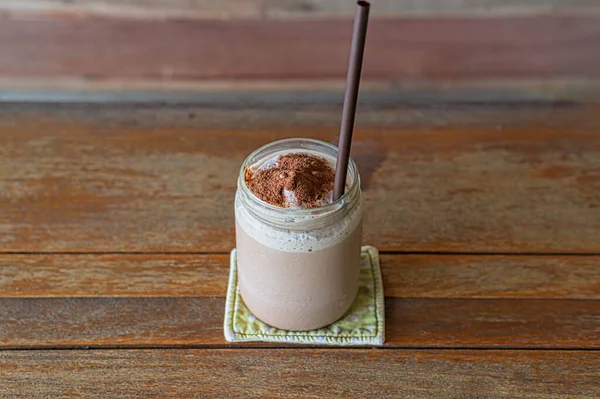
0 297 600 349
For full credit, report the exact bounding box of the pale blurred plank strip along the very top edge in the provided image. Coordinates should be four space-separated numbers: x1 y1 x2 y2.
0 0 599 19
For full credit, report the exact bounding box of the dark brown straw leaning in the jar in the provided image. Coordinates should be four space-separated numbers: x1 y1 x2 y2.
333 1 370 201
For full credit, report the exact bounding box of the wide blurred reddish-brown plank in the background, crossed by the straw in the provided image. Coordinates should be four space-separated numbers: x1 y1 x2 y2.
0 15 600 82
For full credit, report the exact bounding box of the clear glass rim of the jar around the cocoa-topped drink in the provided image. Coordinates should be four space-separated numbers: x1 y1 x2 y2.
238 137 360 217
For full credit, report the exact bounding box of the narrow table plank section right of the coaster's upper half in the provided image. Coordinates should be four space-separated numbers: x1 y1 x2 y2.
381 255 600 299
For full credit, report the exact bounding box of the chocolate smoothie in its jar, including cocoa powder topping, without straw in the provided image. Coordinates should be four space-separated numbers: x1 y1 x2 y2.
235 139 362 330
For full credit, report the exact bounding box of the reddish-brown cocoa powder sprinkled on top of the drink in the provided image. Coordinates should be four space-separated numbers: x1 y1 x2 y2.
244 152 335 208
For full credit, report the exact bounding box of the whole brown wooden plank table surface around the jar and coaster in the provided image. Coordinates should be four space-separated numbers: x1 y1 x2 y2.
0 101 600 398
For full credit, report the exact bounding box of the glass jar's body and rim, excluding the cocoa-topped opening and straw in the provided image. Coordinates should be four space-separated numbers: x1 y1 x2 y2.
235 139 362 331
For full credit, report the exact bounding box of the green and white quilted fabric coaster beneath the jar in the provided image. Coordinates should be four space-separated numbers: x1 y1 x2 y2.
224 246 385 346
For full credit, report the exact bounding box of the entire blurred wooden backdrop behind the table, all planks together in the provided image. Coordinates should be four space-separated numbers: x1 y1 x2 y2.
0 0 600 101
